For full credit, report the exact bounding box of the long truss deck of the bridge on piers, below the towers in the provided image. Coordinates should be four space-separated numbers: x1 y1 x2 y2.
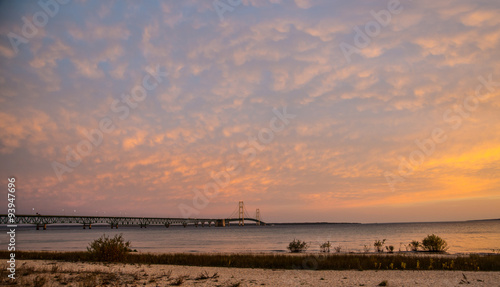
0 214 265 230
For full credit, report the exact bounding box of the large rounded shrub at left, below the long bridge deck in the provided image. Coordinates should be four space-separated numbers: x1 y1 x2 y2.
87 234 130 262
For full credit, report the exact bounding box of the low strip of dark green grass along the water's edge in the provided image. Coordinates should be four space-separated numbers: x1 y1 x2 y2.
0 251 500 271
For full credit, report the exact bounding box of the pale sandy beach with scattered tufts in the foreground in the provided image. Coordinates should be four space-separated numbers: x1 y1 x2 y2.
1 260 500 286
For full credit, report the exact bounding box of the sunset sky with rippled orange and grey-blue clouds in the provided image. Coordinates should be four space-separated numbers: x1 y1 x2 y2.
0 0 500 222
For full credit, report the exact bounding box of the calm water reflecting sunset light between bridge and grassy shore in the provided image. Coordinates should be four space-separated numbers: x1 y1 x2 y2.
0 220 500 253
